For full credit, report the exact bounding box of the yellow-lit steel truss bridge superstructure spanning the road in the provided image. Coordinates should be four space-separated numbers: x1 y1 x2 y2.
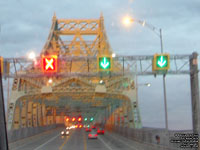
6 15 141 130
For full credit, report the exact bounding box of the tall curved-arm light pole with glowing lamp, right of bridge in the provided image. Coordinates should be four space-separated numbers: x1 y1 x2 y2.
123 17 168 130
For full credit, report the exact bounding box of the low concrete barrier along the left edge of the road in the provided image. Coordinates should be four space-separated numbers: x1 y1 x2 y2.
7 125 63 143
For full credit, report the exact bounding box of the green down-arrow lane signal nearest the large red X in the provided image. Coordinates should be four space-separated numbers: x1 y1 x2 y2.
97 55 112 71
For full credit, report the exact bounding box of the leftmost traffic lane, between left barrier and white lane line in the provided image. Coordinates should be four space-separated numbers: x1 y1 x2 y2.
9 128 63 150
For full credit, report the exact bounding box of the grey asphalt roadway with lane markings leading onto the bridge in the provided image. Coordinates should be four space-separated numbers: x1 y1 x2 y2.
9 128 159 150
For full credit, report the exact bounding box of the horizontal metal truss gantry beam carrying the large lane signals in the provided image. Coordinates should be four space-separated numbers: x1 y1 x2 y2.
3 55 195 78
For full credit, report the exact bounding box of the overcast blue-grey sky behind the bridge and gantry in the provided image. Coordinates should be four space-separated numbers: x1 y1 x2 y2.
0 0 200 129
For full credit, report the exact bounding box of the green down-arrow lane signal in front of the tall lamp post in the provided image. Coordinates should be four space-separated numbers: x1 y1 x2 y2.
152 53 170 71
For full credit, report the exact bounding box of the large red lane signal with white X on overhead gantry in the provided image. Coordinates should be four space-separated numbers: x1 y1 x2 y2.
42 55 57 72
